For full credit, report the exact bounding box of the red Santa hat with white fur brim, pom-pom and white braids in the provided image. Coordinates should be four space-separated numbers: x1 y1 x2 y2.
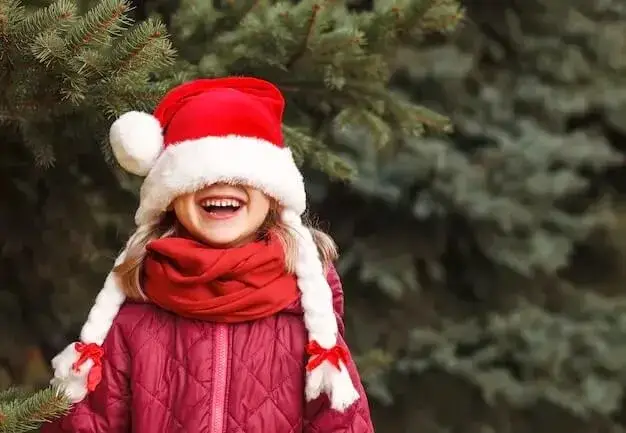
47 77 358 411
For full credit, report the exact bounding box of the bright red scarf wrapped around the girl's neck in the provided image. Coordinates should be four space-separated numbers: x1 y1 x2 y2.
142 236 299 323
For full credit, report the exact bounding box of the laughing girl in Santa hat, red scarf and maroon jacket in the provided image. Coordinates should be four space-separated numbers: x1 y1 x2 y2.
42 77 373 433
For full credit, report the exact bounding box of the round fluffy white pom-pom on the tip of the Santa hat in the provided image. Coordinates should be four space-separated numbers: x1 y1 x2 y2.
109 111 163 176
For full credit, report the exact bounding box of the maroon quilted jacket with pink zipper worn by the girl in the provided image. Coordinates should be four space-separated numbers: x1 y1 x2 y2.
41 269 374 433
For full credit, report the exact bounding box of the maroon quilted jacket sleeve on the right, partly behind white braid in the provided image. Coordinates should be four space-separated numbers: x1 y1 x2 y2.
304 267 374 433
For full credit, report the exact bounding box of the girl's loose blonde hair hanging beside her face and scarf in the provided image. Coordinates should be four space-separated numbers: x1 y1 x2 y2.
113 204 338 299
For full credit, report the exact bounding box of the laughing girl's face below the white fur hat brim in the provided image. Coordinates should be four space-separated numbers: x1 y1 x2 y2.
173 184 270 248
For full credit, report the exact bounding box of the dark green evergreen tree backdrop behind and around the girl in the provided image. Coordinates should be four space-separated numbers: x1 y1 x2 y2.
0 0 626 433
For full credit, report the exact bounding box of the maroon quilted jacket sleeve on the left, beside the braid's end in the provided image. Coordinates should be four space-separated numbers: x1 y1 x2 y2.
40 316 131 433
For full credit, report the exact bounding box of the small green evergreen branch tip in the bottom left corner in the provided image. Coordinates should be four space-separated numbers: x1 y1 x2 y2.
0 387 71 433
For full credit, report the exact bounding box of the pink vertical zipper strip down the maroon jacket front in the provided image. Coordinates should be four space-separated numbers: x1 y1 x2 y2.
210 323 229 433
